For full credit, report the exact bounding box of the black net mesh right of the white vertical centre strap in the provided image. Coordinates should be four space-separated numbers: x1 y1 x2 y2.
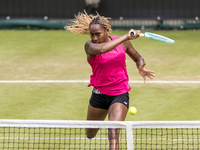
133 128 200 150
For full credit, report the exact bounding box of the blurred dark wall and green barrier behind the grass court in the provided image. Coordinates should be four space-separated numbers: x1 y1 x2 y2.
0 0 200 30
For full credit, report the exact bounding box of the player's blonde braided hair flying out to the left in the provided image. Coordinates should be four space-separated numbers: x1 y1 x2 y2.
65 10 112 34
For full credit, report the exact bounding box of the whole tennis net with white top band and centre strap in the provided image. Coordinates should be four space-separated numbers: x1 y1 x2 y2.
0 120 200 150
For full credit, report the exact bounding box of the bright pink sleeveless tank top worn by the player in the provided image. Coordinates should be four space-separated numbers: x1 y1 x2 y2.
88 36 131 96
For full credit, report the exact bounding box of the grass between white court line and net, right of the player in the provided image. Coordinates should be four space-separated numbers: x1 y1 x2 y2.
127 84 200 121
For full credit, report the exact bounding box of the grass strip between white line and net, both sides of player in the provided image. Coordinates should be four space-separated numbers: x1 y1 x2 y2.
0 83 200 121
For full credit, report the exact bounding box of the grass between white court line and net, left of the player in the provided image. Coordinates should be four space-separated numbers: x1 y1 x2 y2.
0 83 90 120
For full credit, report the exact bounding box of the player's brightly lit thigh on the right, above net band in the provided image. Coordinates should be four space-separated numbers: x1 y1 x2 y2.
108 102 128 121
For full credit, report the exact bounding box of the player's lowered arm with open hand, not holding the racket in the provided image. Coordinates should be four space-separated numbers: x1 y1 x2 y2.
122 41 155 82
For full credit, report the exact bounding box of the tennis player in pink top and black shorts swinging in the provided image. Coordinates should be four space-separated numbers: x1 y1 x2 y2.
65 11 155 150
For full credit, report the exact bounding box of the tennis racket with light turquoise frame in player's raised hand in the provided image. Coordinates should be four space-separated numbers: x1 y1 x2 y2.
131 32 175 44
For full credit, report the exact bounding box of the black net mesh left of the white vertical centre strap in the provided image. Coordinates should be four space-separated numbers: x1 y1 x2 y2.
0 127 127 150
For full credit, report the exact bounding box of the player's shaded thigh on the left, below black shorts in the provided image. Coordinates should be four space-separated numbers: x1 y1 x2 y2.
87 105 108 120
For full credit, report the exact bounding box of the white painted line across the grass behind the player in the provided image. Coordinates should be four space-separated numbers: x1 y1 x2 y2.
0 80 200 84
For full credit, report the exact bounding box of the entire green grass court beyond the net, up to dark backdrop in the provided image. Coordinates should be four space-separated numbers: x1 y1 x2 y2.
0 30 200 121
